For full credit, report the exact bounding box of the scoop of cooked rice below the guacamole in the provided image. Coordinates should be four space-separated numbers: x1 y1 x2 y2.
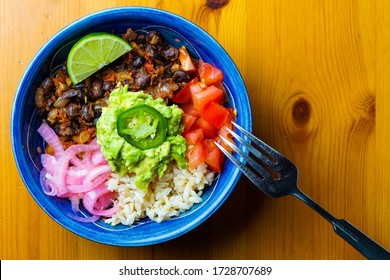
105 164 214 226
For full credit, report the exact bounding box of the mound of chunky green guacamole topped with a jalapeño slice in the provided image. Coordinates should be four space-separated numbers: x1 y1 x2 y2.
96 86 187 191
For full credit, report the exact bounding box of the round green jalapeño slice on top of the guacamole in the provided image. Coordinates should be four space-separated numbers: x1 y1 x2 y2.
116 105 167 150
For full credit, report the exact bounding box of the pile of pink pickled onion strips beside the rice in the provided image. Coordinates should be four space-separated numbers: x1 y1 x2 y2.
38 123 118 222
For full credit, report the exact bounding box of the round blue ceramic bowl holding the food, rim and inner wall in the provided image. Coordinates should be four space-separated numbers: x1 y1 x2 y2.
11 7 252 246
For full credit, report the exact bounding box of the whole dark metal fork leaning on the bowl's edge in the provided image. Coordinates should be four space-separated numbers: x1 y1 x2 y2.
216 122 390 260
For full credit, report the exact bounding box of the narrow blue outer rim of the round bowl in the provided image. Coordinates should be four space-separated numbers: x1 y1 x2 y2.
10 6 252 247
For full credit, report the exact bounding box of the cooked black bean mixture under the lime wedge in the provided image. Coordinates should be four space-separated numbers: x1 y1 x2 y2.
35 28 196 146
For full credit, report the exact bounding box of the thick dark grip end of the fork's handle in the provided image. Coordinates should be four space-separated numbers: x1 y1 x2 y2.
331 219 390 260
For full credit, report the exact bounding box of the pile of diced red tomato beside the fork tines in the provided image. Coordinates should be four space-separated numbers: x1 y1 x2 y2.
173 58 235 173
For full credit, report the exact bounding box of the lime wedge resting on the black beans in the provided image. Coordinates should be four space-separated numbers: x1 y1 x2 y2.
67 32 132 84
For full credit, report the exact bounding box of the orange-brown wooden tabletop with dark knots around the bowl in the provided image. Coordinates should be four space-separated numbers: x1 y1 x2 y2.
0 0 390 259
